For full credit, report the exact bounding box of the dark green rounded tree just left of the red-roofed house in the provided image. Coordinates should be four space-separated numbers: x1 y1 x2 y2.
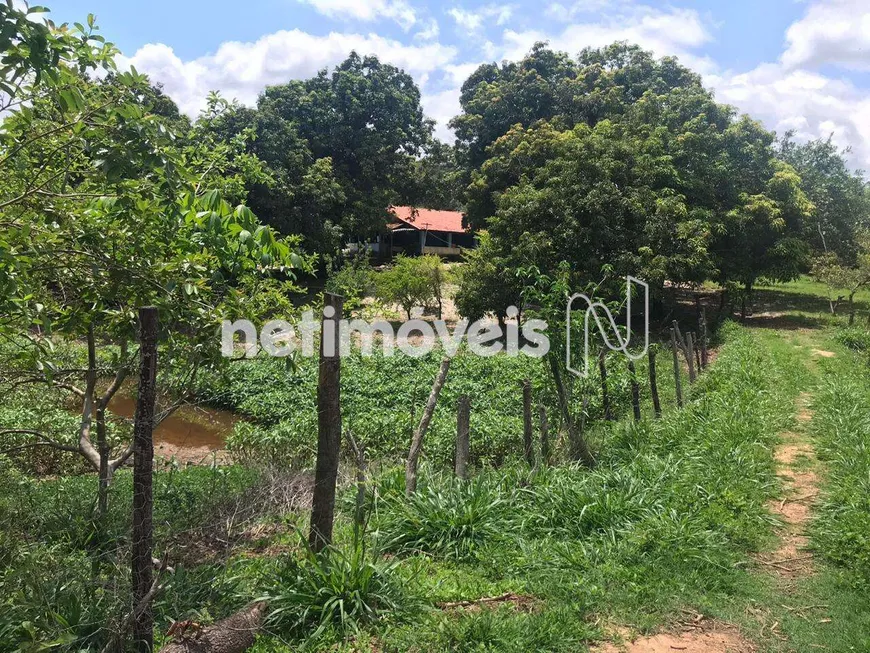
256 52 432 246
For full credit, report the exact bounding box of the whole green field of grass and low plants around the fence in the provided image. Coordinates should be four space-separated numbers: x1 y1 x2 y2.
0 281 870 653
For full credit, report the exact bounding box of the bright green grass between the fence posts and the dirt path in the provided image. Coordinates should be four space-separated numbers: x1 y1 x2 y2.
254 327 805 651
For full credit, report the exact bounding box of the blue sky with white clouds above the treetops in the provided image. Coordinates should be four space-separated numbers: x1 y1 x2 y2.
46 0 870 170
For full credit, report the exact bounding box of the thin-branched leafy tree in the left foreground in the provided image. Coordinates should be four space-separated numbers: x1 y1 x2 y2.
0 5 309 520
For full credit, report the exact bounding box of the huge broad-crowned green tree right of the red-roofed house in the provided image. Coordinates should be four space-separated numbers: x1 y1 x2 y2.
454 44 813 318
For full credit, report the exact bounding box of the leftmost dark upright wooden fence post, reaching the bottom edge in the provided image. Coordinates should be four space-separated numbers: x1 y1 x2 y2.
130 306 158 653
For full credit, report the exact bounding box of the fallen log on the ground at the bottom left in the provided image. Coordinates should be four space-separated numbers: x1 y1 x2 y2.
159 602 266 653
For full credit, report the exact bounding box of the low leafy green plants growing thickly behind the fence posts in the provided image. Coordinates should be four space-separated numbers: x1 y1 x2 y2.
198 338 688 468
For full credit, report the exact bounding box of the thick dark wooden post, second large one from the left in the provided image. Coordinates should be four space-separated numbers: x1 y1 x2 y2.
308 293 344 552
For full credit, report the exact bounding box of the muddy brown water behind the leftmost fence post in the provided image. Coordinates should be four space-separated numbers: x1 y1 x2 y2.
109 388 239 464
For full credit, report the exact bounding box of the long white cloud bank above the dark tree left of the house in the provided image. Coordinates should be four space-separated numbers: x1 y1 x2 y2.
119 29 456 116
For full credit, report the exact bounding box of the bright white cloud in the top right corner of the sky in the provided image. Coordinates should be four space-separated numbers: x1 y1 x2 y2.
782 0 870 70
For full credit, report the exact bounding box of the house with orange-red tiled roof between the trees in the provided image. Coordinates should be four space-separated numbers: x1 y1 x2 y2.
378 206 474 257
